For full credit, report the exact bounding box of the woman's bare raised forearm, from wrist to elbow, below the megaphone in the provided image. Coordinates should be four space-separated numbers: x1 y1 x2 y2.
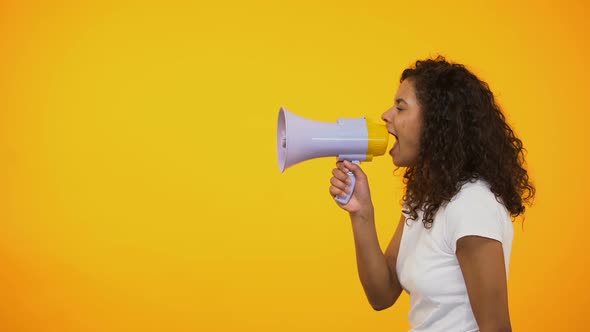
350 211 401 310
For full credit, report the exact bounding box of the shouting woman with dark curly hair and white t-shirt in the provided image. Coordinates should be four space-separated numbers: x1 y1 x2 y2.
330 56 535 332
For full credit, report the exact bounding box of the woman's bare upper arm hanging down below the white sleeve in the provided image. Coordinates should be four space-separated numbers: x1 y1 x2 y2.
457 236 511 332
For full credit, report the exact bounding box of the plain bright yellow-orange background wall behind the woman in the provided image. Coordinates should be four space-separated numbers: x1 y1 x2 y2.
0 0 590 332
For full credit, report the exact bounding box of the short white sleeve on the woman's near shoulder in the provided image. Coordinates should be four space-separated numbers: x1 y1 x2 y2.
445 185 504 253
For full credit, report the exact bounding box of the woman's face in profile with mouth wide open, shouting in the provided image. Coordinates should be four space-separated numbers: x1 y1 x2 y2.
381 79 422 167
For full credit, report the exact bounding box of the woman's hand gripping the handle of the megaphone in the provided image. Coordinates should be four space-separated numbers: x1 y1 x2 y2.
330 160 373 215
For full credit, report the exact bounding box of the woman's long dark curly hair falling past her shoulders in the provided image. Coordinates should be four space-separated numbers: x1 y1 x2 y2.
400 56 535 228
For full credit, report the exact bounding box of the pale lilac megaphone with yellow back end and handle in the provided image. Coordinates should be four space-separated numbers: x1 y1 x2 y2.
277 107 389 205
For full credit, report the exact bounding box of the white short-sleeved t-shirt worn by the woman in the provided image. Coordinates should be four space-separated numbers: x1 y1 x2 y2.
396 180 514 332
